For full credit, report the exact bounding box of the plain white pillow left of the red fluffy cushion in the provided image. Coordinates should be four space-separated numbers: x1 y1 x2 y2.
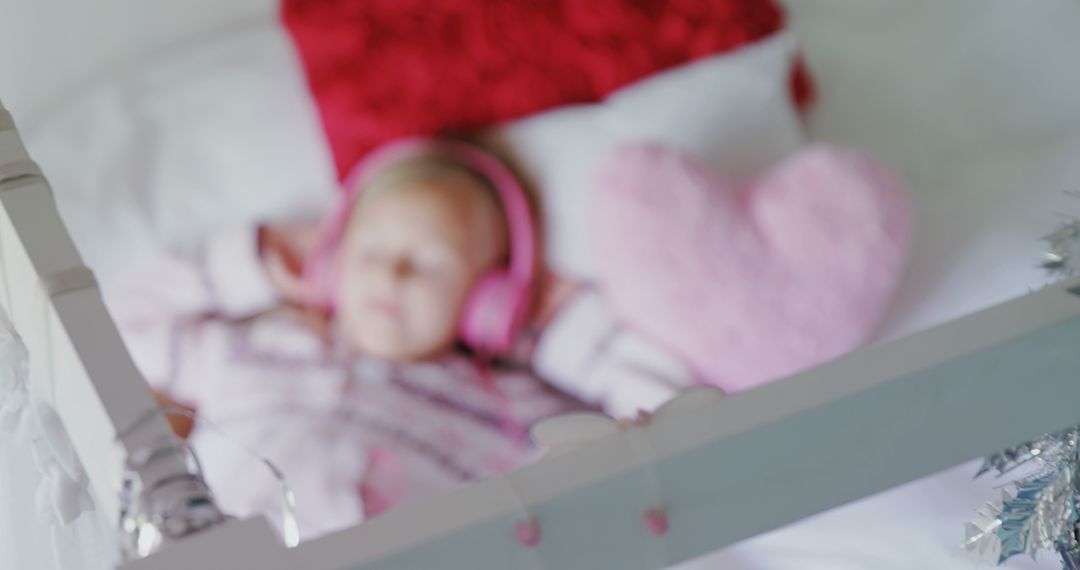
26 25 336 281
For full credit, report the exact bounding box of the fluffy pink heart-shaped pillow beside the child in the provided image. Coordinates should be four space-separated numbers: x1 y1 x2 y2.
592 146 912 391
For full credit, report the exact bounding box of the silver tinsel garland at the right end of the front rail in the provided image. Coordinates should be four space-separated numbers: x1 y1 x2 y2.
964 211 1080 570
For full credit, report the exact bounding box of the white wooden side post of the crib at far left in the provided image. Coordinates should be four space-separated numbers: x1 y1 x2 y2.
0 98 248 554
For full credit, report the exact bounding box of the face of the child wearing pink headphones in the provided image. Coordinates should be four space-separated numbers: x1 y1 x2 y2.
337 173 505 361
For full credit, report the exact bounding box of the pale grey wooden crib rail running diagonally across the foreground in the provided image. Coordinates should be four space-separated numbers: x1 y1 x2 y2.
295 282 1080 570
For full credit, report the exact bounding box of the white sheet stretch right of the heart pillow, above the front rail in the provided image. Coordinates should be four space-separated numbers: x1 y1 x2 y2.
788 0 1080 337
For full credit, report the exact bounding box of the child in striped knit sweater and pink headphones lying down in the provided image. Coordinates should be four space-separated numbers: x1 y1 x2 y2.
108 138 691 538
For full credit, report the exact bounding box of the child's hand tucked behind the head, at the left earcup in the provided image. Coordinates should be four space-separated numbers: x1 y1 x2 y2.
258 222 319 306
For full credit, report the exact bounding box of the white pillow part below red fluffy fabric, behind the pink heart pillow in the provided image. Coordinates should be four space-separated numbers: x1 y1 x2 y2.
491 33 804 279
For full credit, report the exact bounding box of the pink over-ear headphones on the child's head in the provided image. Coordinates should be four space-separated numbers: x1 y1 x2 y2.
305 137 537 354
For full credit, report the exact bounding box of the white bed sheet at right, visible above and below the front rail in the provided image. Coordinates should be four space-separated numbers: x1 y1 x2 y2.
678 0 1080 570
